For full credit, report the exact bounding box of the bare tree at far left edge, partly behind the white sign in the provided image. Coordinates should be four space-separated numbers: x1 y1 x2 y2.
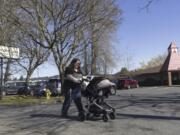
0 0 17 83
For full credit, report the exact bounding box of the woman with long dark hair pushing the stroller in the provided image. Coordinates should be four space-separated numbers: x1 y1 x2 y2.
62 58 85 121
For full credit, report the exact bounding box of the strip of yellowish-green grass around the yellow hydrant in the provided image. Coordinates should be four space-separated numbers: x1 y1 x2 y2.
0 96 63 105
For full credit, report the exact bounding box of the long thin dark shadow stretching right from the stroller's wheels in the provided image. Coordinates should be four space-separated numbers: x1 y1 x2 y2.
116 113 180 120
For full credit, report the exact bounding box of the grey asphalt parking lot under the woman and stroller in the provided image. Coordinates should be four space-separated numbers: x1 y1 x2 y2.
0 86 180 135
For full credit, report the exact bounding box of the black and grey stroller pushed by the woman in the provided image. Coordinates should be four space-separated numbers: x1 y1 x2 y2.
82 76 116 122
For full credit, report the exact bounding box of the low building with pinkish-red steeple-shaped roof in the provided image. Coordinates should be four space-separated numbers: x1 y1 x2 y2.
120 42 180 86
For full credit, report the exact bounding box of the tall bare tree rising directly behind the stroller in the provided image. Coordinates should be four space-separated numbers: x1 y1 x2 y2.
81 0 121 74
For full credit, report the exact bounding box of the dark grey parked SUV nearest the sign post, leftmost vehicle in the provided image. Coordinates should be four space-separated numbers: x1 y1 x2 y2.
3 81 26 95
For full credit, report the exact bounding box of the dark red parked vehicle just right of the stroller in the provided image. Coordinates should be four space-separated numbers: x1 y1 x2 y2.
117 78 139 89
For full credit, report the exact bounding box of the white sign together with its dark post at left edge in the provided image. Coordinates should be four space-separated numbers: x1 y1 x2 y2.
0 46 19 100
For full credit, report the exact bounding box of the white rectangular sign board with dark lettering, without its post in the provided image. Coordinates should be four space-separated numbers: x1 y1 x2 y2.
0 46 19 59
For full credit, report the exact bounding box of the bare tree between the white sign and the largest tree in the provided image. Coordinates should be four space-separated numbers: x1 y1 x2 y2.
2 0 50 84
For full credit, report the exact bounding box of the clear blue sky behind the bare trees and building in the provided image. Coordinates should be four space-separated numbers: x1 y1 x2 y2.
33 0 180 76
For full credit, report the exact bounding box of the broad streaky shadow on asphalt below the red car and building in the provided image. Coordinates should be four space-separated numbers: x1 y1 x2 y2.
111 92 180 112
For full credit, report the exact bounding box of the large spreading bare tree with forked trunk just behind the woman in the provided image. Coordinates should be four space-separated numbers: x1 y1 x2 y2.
6 0 90 82
